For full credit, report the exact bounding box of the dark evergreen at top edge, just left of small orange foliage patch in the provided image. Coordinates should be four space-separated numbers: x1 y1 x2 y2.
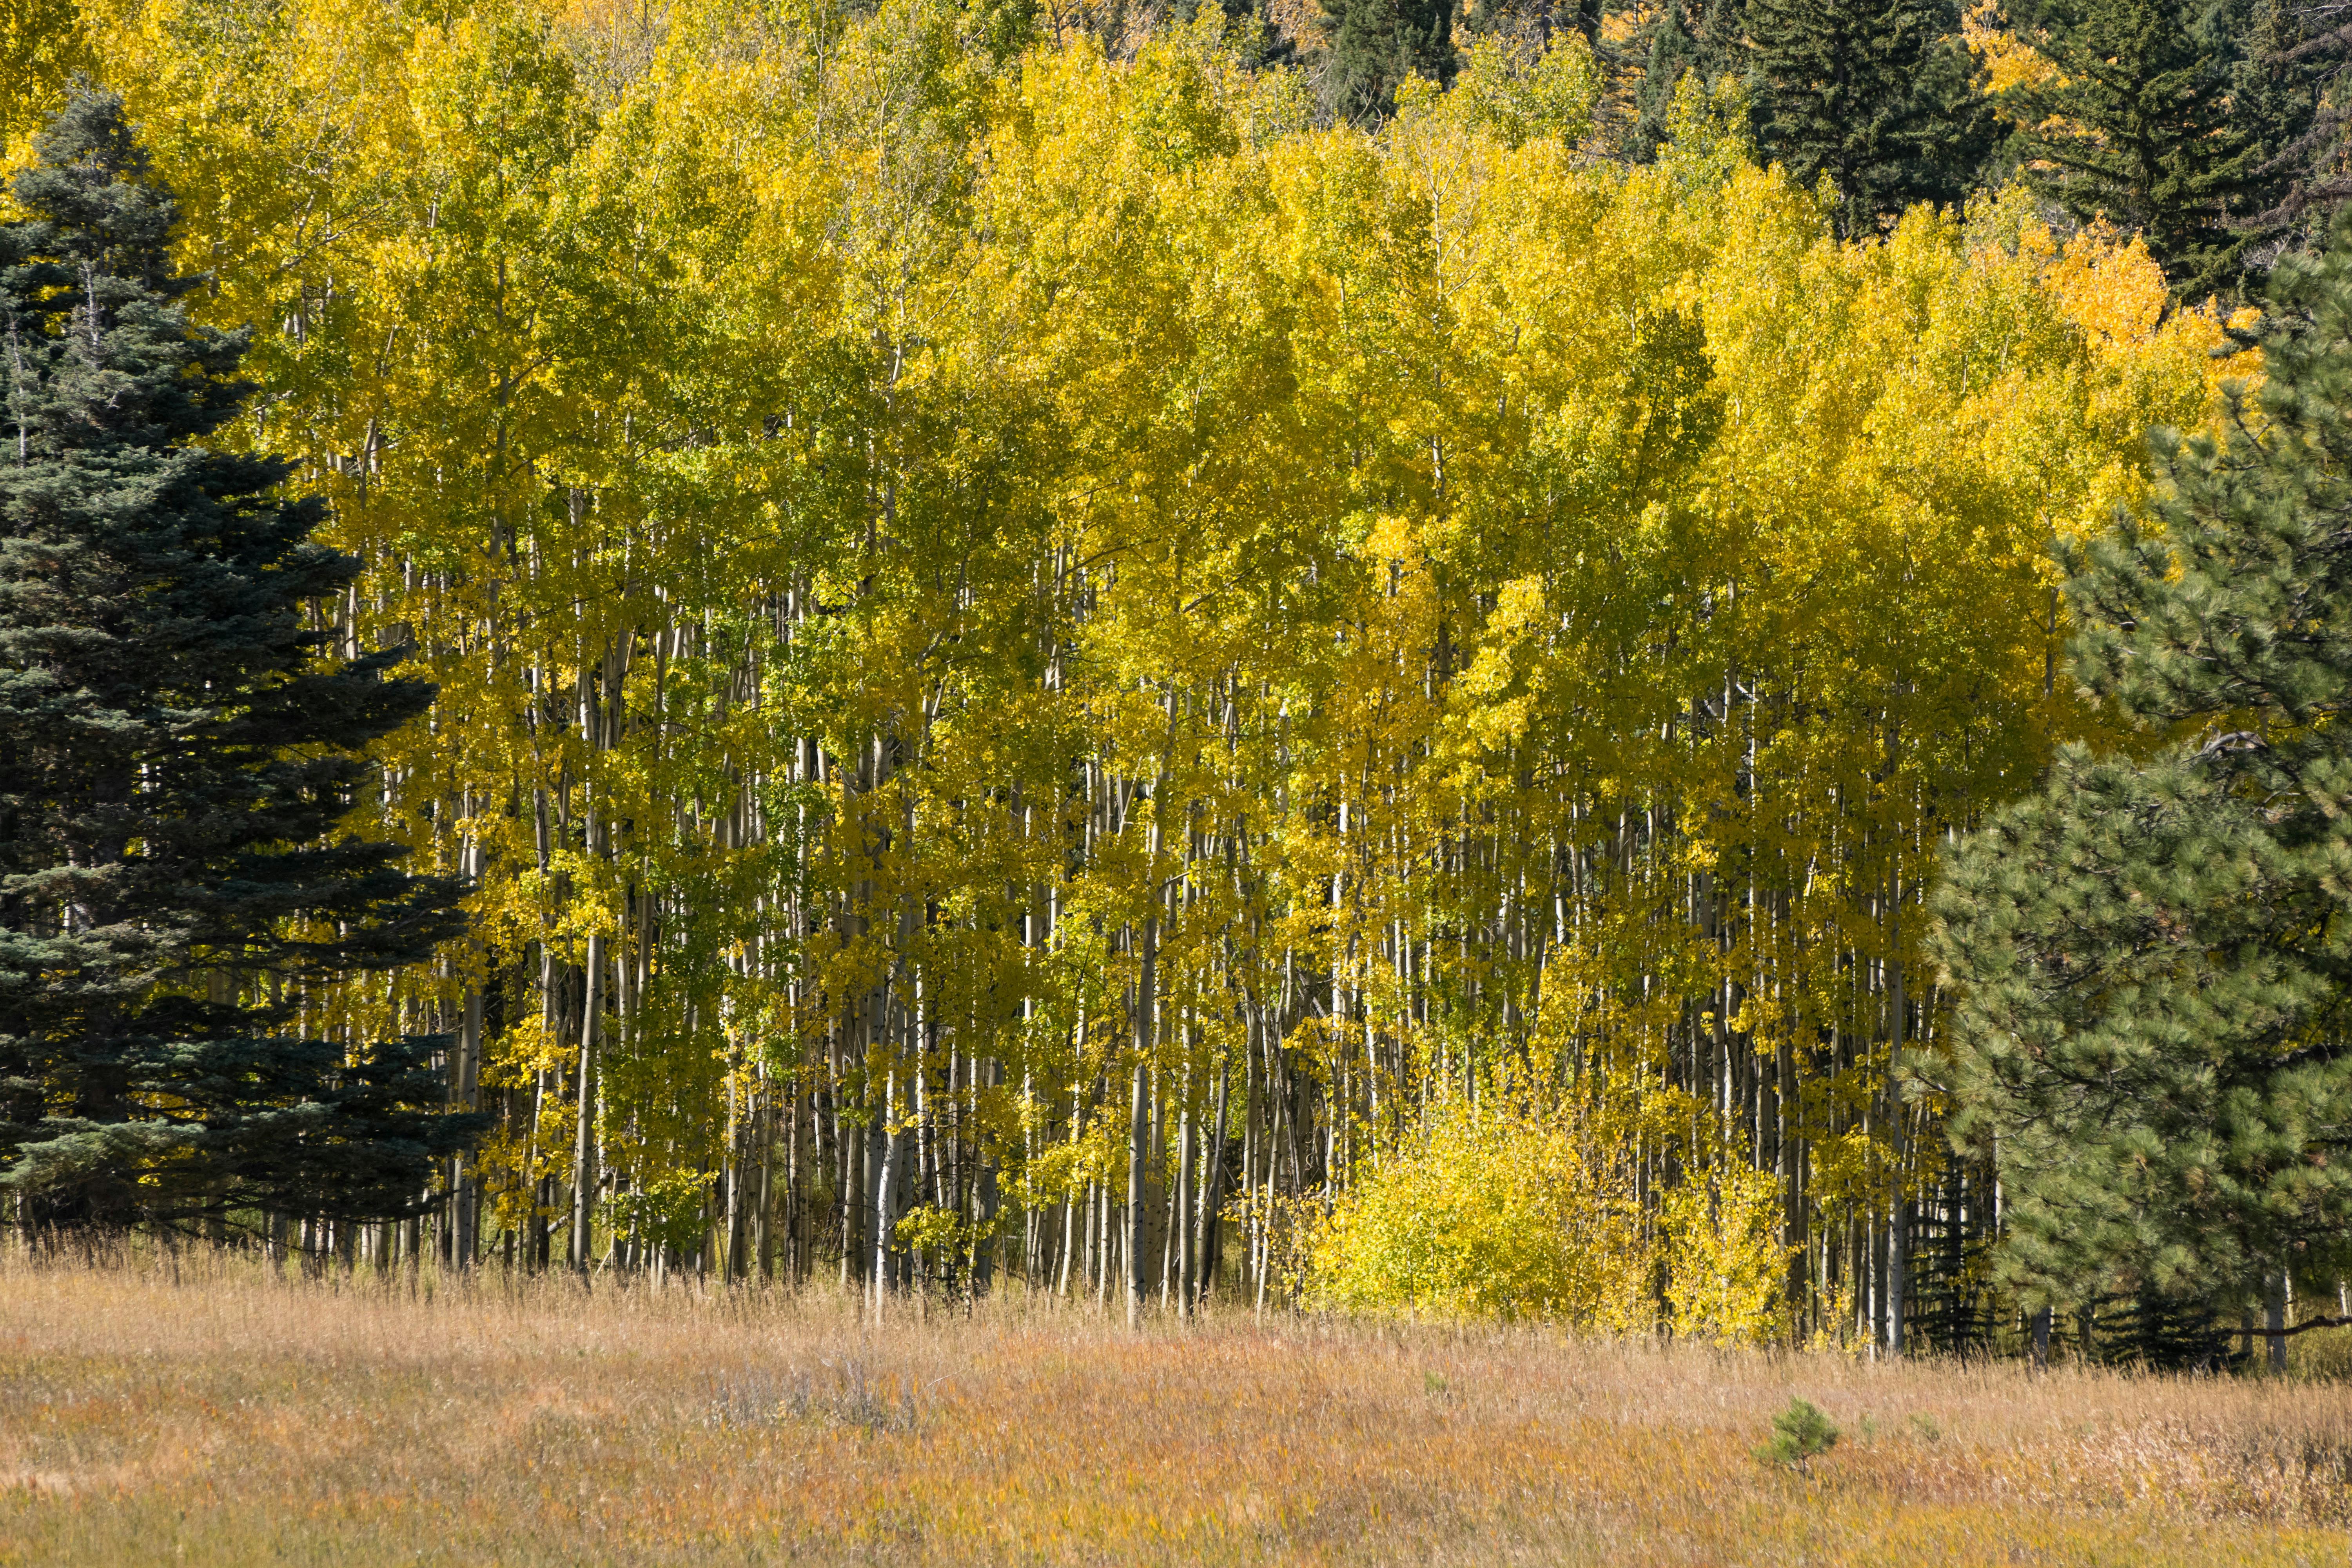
1748 0 1994 238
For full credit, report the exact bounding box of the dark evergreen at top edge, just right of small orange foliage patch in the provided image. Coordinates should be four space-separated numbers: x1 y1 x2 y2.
2018 0 2277 299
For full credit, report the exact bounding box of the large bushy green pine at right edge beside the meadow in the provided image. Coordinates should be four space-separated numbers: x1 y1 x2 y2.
1922 223 2352 1347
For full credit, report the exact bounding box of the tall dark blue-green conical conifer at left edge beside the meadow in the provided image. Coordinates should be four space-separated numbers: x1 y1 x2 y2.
0 89 473 1227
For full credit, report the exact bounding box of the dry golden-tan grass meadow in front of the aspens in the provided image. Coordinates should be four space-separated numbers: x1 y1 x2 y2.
0 1262 2352 1566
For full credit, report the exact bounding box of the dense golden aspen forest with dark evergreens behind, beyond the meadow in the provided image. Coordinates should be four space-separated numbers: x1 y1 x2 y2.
0 0 2345 1347
